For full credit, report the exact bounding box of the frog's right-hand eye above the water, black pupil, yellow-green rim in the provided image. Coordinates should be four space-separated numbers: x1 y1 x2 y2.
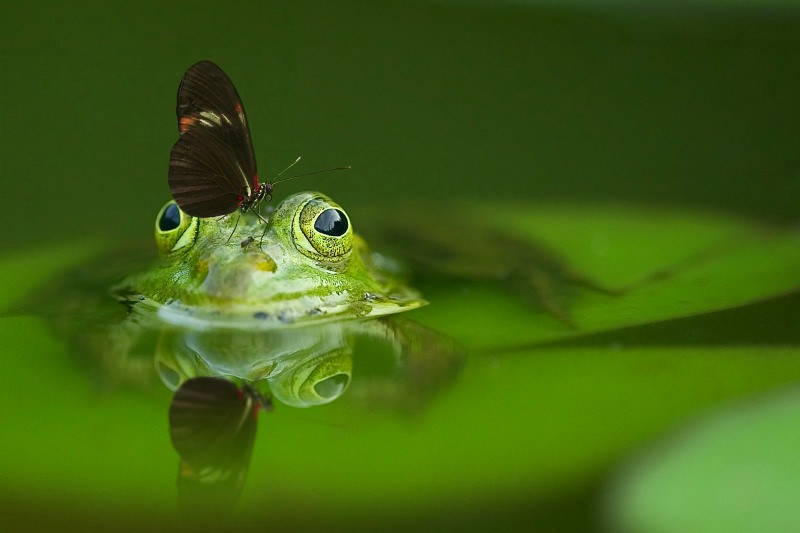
292 196 353 262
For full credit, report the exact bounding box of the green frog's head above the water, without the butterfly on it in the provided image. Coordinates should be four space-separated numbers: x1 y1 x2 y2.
114 192 427 329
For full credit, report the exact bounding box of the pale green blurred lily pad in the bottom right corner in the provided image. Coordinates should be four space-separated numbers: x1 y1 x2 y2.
607 387 800 533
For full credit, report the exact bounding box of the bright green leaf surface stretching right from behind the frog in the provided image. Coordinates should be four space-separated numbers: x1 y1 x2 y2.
416 204 800 350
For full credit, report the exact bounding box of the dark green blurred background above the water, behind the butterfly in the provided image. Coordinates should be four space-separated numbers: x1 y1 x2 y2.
0 0 800 251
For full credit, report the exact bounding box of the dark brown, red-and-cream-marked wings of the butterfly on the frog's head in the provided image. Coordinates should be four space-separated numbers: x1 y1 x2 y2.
169 61 258 217
